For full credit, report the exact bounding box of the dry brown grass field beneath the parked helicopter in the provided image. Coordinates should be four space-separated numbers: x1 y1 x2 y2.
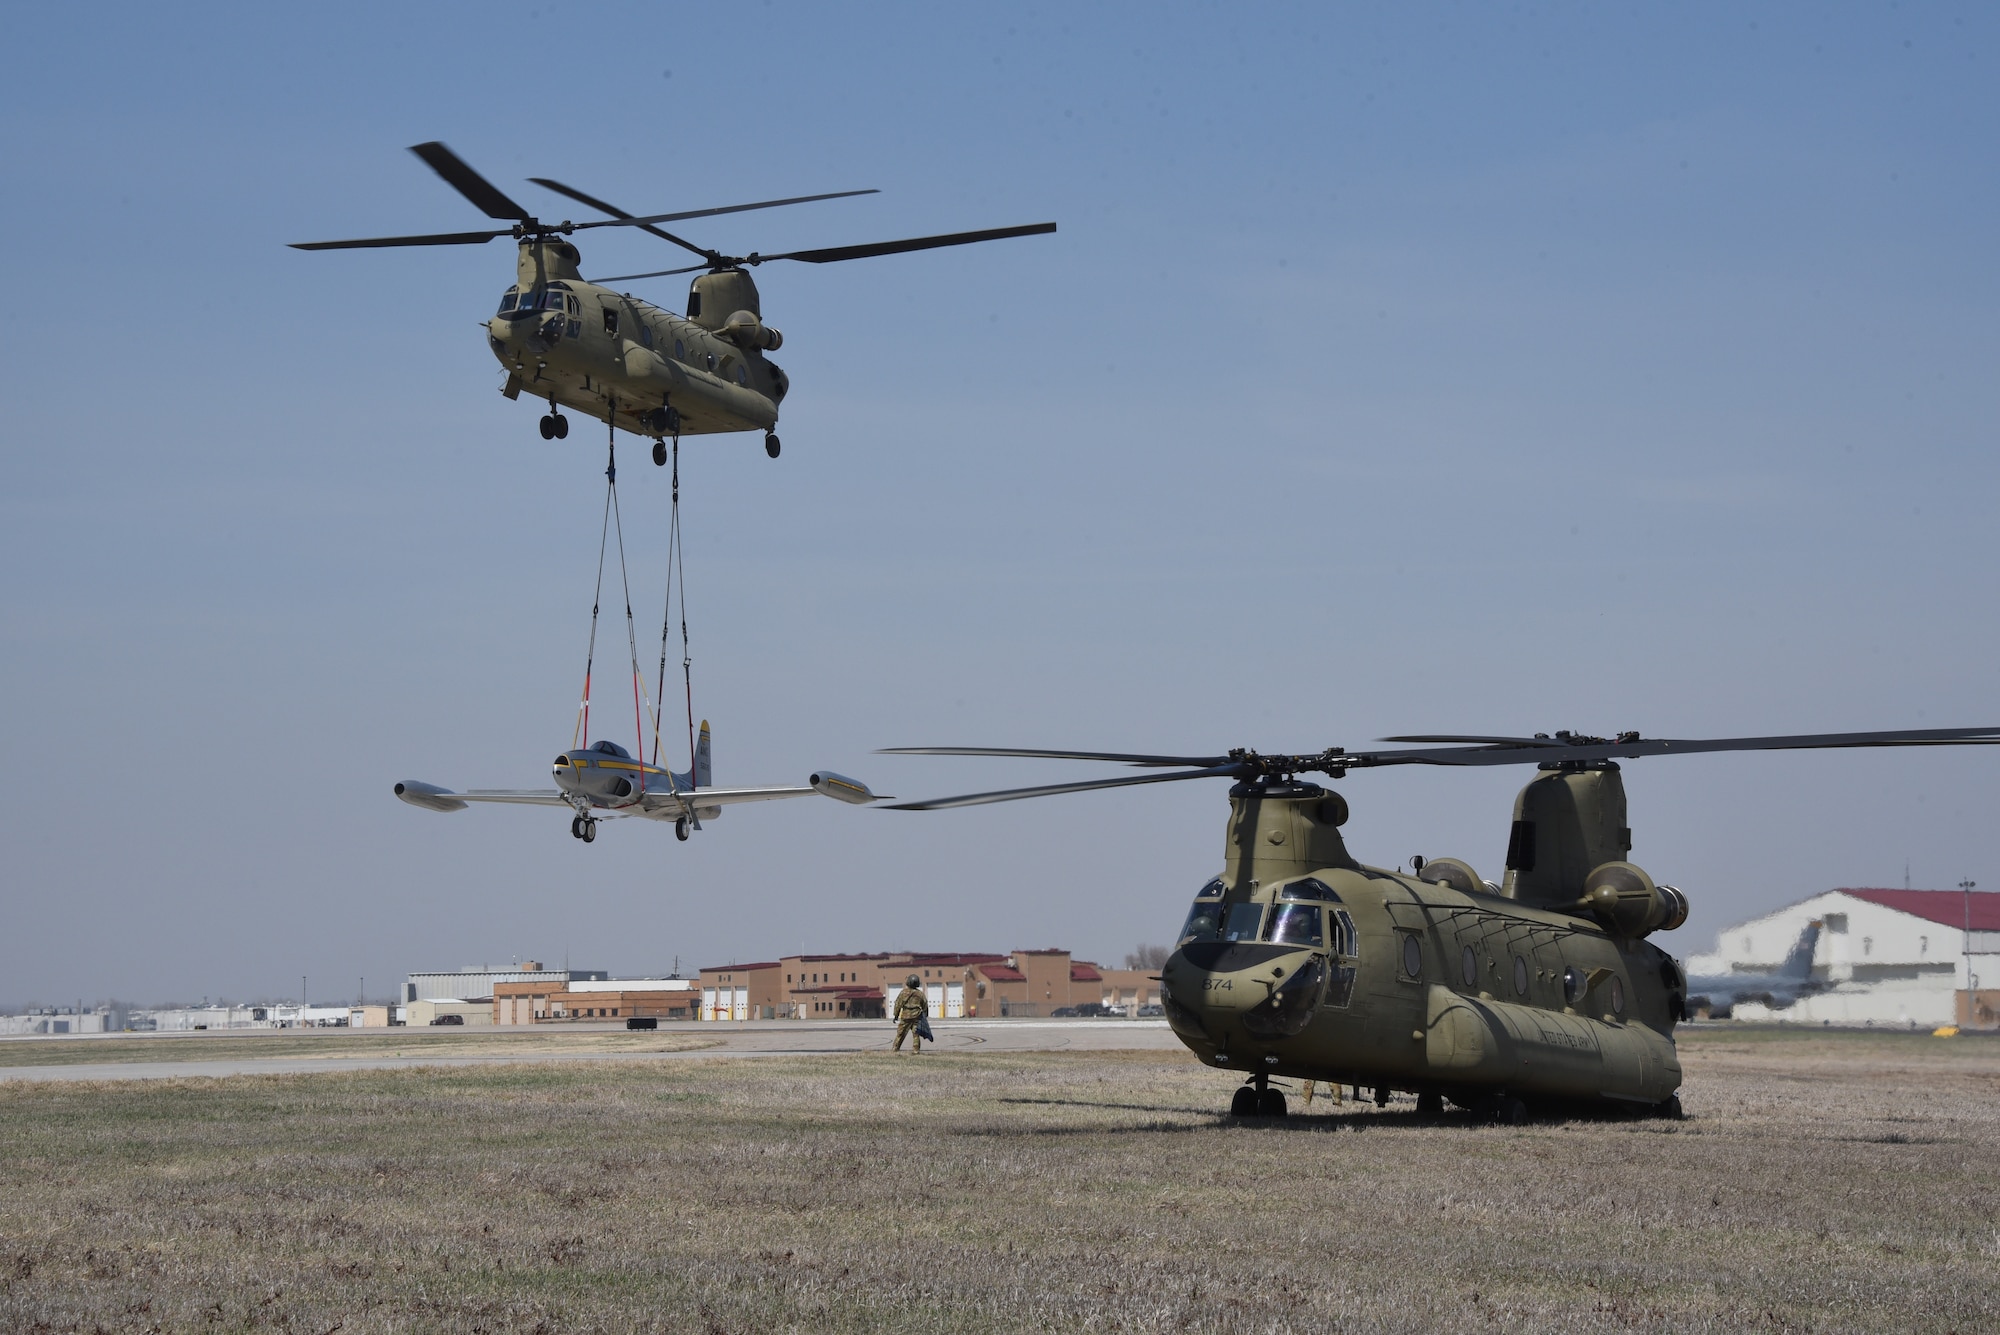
0 1029 2000 1335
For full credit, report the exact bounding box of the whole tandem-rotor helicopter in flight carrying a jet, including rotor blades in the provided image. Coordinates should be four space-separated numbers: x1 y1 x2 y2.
294 142 1056 466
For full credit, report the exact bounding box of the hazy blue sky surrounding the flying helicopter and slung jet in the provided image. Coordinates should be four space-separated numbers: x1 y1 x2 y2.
0 4 2000 1001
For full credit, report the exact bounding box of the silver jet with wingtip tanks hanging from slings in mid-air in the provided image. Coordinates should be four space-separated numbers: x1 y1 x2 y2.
396 719 882 843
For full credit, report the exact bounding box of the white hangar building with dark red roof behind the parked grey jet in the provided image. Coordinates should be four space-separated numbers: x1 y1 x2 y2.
1684 889 2000 1029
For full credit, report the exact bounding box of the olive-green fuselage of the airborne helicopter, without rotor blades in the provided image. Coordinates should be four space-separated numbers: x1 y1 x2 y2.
486 240 790 436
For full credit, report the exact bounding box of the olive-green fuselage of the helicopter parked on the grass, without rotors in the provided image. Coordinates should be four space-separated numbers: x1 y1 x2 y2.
1162 775 1684 1109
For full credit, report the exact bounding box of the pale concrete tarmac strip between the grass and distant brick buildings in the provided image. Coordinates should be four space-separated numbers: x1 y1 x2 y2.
0 1019 1180 1083
